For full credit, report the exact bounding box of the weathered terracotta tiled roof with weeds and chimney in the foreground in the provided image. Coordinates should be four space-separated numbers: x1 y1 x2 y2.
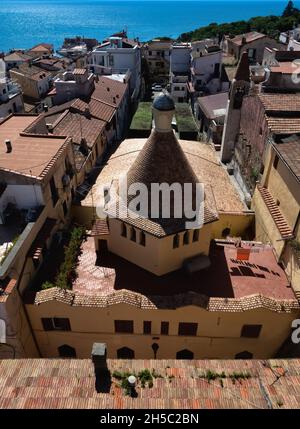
0 359 300 411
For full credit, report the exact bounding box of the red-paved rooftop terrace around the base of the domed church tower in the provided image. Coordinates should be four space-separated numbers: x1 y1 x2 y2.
69 237 296 306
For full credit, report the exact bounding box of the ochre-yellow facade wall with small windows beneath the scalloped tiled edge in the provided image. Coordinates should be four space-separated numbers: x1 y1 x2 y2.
27 301 299 359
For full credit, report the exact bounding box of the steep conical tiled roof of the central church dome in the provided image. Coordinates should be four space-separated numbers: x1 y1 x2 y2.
108 130 218 237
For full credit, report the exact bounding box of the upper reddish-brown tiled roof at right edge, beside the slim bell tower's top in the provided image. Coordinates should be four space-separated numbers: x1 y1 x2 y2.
258 93 300 112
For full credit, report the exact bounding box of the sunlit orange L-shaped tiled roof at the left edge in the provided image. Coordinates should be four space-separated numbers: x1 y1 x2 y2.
0 115 68 179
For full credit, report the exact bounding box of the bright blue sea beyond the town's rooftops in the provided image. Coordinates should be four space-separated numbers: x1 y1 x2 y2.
0 0 300 51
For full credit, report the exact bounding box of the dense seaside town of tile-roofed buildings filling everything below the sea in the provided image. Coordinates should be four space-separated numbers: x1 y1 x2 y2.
0 21 300 409
